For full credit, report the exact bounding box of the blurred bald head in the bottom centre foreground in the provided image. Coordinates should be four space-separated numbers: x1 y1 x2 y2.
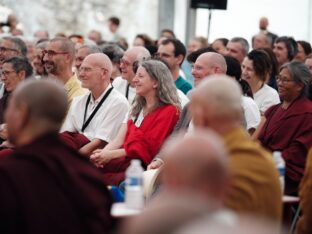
162 130 228 203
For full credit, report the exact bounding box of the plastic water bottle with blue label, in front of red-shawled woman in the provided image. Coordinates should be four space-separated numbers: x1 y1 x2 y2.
125 159 144 209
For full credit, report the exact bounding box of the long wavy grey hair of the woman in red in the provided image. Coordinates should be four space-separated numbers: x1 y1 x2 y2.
131 59 181 117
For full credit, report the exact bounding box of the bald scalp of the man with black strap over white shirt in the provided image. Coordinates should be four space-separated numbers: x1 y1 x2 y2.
83 53 113 77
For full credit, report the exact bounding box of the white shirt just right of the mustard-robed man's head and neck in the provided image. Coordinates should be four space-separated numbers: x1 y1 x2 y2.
241 96 261 130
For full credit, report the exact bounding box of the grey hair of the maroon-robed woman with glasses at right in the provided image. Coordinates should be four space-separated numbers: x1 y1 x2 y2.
280 61 311 97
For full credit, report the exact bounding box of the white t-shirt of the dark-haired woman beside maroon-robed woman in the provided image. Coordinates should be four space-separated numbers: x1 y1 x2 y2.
254 84 281 113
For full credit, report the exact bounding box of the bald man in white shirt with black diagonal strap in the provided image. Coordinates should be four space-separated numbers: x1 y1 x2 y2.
61 53 129 156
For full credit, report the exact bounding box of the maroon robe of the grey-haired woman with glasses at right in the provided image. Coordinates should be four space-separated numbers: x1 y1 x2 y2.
259 97 312 194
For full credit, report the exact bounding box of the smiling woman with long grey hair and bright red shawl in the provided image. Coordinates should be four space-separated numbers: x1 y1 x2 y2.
90 60 181 185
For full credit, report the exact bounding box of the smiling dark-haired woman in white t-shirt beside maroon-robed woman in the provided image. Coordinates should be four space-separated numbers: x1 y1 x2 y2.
242 50 280 114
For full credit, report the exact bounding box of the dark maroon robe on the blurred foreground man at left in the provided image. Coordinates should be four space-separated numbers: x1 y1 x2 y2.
0 134 112 234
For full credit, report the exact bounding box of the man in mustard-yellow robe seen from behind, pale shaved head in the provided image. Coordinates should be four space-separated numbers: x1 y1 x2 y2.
190 75 282 222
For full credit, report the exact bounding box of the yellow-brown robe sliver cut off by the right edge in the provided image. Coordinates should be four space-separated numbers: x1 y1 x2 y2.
296 150 312 234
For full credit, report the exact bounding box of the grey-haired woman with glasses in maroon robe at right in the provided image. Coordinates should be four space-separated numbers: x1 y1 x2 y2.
258 62 312 195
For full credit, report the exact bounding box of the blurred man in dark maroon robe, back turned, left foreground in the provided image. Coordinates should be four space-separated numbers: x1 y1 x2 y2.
0 80 112 234
